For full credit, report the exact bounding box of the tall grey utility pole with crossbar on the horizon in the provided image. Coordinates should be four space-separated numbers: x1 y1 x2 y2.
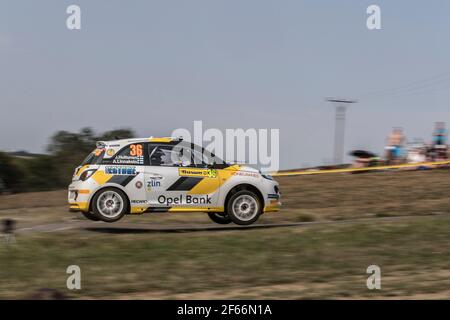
325 98 358 164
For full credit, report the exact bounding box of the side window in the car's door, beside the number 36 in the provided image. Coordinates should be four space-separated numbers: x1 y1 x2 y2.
149 146 191 167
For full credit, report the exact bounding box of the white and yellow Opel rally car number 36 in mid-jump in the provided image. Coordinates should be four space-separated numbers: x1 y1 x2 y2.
68 137 280 225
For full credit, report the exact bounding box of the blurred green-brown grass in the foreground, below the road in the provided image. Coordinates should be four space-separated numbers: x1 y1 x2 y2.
0 216 450 299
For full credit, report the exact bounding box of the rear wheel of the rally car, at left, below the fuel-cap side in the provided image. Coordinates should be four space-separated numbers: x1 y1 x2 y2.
92 188 129 222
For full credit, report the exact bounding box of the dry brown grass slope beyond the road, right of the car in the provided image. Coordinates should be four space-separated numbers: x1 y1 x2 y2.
276 169 450 221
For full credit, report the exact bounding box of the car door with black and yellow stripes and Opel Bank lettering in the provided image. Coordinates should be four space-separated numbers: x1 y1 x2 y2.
145 144 219 209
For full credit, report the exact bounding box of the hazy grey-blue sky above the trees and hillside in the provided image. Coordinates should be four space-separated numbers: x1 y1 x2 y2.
0 0 450 169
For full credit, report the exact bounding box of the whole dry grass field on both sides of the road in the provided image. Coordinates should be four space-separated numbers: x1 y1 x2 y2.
0 171 450 299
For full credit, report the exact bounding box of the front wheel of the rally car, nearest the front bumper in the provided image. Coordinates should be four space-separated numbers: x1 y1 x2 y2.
226 190 262 226
